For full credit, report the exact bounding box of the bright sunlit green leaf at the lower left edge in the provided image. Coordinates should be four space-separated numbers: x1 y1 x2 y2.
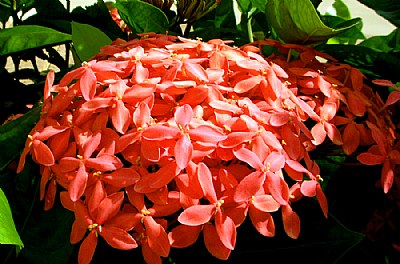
0 189 24 249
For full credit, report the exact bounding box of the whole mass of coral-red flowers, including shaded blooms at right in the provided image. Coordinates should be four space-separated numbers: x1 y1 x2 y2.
18 34 400 263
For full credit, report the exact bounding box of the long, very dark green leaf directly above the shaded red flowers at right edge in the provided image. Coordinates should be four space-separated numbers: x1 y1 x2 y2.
317 44 400 82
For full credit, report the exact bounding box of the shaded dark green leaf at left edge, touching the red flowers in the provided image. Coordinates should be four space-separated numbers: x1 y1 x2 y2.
0 107 40 171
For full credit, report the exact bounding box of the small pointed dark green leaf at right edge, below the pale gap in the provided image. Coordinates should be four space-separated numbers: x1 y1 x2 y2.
359 28 400 53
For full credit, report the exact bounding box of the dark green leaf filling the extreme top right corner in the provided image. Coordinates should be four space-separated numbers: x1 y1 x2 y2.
358 0 400 27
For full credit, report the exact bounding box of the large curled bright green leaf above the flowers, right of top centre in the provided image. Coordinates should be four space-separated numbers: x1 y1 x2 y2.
266 0 361 44
